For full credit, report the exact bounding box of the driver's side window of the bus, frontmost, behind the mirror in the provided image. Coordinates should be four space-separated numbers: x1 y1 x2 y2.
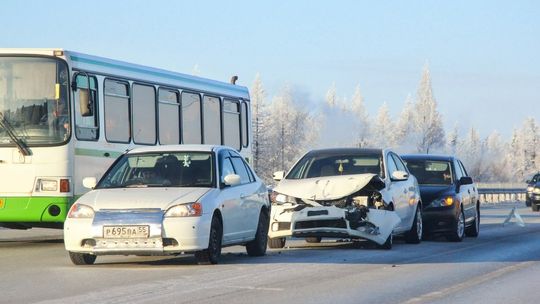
75 73 99 140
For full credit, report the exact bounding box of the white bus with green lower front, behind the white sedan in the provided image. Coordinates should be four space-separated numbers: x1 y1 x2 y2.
0 49 251 229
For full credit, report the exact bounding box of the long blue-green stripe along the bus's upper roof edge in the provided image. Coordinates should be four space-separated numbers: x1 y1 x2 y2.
70 55 246 94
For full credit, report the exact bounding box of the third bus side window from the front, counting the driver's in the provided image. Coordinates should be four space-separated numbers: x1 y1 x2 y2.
132 84 156 145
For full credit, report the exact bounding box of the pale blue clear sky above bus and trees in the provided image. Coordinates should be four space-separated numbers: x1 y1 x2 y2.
0 0 540 139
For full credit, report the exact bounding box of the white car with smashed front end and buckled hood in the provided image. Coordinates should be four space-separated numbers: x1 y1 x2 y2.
268 148 422 249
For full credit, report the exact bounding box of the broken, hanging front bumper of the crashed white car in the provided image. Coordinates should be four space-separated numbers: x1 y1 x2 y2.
268 204 400 245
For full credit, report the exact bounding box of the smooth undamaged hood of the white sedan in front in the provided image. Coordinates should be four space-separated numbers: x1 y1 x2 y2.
77 188 210 211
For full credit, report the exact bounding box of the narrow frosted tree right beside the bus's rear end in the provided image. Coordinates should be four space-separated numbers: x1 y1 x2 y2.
251 73 270 172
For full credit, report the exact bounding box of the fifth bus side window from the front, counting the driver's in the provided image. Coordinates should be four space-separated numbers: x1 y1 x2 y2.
182 92 202 144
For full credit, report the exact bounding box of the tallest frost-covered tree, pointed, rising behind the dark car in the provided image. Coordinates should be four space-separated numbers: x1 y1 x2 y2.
414 64 444 153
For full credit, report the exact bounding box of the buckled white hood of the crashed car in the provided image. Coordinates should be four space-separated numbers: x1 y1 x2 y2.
274 174 385 200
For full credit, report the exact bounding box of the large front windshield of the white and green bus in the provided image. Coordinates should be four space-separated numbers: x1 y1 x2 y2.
0 56 70 146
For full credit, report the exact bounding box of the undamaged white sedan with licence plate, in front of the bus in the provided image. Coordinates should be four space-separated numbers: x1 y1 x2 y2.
64 145 270 265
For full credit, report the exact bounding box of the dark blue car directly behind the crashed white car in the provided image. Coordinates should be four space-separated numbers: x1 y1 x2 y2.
401 154 480 242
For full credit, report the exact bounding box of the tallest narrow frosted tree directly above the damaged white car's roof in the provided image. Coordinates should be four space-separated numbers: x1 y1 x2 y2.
345 85 370 148
